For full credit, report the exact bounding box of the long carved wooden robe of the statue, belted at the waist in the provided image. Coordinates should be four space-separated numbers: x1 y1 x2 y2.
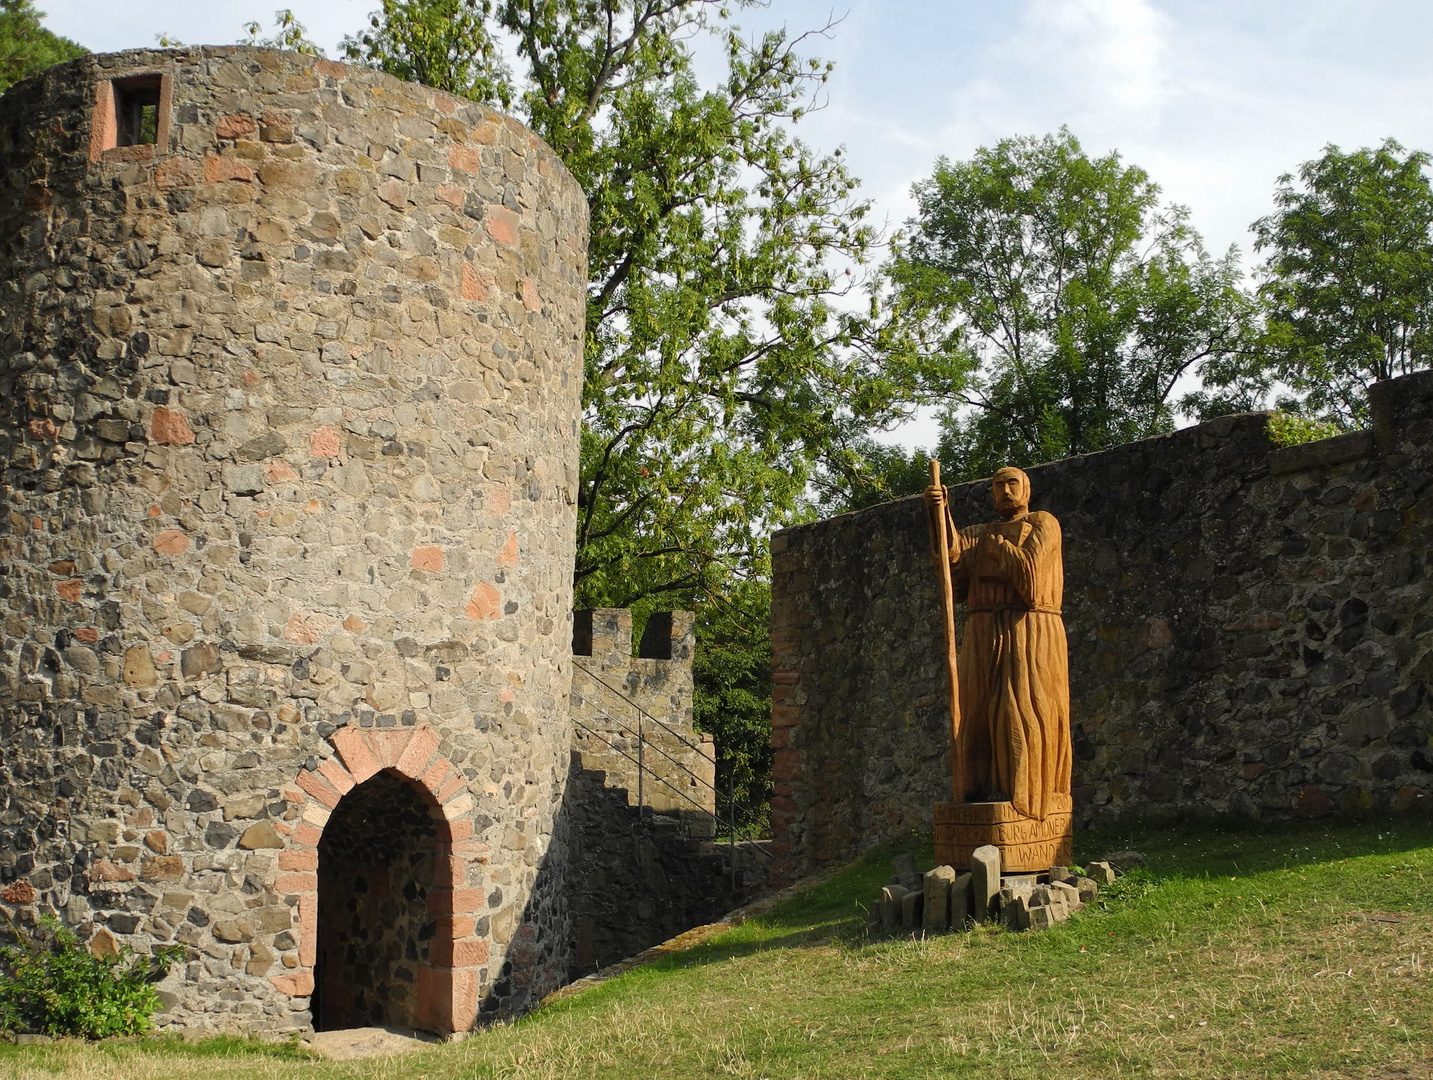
950 495 1070 821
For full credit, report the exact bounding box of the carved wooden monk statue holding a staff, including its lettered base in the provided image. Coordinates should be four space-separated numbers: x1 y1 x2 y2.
926 468 1070 872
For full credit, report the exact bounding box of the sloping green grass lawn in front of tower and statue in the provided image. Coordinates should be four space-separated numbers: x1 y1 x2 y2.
0 822 1433 1080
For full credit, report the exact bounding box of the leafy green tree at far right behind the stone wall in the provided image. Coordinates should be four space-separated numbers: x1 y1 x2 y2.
1254 139 1433 428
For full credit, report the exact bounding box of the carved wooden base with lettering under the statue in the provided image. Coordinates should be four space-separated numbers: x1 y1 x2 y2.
936 794 1075 874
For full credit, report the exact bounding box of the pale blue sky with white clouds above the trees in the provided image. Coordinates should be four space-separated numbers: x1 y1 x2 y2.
39 0 1433 441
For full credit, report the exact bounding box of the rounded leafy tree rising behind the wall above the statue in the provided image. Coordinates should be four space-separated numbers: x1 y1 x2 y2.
887 129 1251 478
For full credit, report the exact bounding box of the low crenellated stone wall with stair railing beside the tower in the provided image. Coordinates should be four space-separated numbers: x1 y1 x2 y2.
563 607 768 975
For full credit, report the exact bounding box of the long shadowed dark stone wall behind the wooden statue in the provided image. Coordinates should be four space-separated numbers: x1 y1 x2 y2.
772 372 1433 879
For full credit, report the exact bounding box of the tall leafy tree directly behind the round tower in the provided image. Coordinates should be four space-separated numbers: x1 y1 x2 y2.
347 0 903 606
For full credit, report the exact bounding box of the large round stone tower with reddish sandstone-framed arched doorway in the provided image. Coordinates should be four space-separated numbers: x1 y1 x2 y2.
0 47 586 1031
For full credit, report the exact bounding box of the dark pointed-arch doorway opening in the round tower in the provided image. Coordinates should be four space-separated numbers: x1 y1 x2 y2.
312 769 440 1031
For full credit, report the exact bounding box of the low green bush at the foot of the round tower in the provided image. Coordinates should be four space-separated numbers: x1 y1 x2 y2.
0 915 185 1038
